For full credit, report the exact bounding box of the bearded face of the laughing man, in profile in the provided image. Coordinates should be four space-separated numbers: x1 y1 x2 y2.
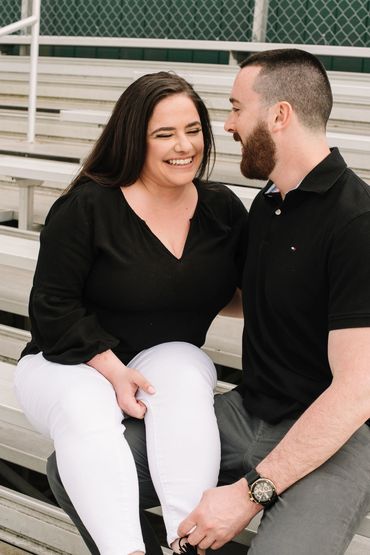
225 66 276 180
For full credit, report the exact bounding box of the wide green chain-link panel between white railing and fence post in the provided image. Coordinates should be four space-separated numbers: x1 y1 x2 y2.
41 0 254 40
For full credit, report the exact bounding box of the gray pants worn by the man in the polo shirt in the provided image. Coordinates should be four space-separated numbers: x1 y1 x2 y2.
48 391 370 555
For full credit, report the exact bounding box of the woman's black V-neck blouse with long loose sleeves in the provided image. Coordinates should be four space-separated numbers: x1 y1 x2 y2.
22 181 247 364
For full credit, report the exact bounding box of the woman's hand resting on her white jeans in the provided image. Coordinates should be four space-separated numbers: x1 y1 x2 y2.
87 350 155 418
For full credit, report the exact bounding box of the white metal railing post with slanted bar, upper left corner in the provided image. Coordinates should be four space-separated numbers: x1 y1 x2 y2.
0 0 41 142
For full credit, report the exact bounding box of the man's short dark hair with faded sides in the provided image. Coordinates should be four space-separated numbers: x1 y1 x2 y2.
240 48 333 130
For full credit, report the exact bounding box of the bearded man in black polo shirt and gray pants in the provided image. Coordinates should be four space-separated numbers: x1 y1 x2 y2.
49 49 370 555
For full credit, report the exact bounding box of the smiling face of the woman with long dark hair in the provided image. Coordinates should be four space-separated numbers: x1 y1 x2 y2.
140 94 204 187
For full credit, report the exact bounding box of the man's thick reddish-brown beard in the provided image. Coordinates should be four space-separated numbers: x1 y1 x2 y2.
234 122 276 181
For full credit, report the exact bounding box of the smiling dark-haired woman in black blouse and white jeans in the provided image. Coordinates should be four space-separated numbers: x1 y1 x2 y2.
16 72 247 555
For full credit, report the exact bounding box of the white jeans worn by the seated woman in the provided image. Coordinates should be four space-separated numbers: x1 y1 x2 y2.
15 342 220 555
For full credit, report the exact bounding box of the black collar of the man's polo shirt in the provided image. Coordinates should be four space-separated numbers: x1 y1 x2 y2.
263 147 347 195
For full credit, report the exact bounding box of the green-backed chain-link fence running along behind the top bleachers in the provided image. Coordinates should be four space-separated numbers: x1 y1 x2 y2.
0 0 370 46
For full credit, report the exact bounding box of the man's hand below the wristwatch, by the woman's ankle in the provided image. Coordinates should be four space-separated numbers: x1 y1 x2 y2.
178 478 261 549
